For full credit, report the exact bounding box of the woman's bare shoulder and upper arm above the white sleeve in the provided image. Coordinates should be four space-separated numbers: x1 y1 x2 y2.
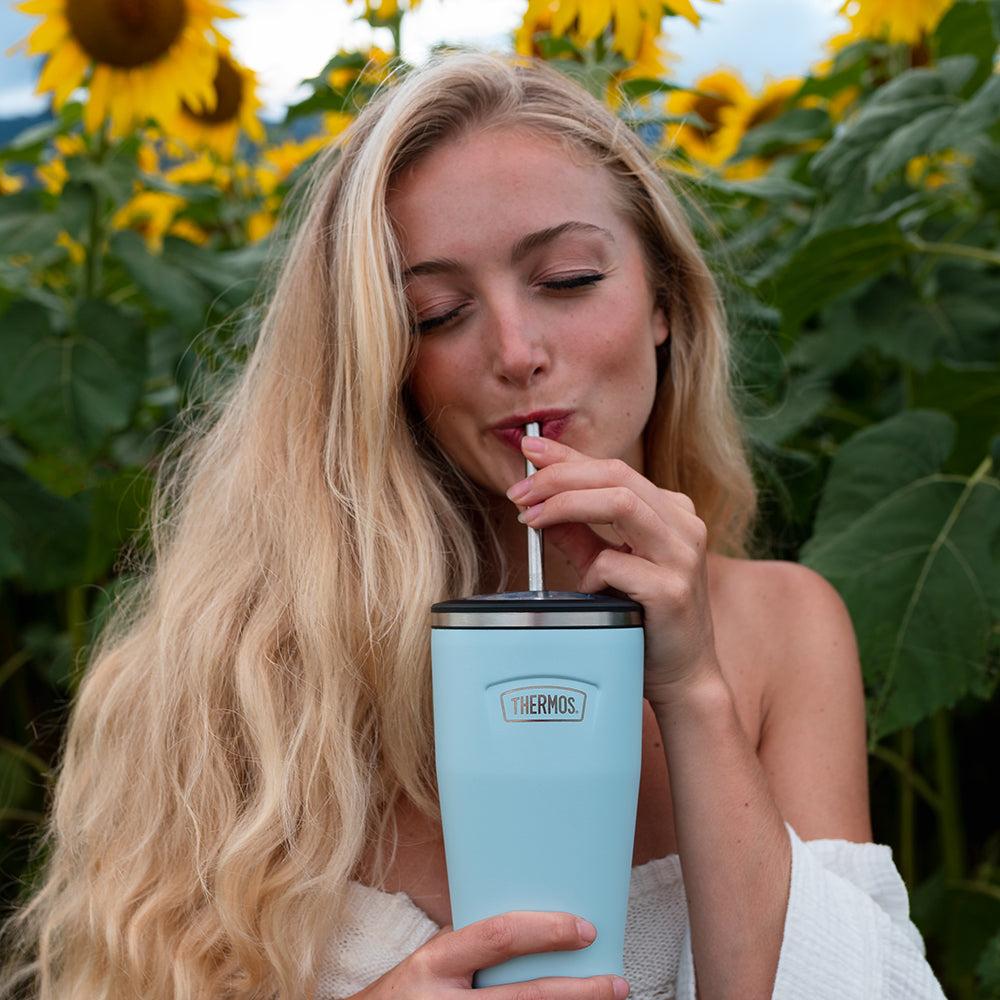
709 557 871 840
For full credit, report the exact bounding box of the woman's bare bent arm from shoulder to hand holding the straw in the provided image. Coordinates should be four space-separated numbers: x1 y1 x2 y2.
511 438 932 1000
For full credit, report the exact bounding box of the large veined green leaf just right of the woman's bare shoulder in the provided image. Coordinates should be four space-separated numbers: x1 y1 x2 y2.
802 411 1000 743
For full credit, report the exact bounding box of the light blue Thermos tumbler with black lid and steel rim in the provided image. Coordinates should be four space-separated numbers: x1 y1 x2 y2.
431 590 643 986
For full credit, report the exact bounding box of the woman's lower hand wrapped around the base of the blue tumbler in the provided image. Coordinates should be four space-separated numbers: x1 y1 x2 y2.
355 911 628 1000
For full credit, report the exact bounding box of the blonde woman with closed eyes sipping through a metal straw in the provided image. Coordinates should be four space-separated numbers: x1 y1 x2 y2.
3 55 941 1000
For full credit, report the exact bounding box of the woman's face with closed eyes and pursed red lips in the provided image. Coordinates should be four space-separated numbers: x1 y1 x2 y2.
389 129 668 493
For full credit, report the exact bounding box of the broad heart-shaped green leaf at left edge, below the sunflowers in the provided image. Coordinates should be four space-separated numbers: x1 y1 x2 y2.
0 301 146 453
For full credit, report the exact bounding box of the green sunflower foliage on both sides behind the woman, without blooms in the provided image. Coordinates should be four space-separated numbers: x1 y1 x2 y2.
0 0 1000 1000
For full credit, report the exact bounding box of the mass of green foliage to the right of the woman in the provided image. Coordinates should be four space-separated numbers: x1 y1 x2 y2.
702 2 1000 1000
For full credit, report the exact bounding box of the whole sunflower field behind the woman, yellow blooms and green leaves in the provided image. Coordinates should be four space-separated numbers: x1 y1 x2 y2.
0 0 1000 1000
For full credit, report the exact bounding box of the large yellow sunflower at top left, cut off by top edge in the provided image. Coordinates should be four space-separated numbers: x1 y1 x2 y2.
18 0 236 136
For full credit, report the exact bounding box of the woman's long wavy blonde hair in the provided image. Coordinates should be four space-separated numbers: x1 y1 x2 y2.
0 55 753 1000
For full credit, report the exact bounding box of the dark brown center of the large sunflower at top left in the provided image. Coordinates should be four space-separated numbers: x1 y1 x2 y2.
66 0 187 69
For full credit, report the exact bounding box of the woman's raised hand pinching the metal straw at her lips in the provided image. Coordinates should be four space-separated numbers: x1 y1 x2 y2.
507 437 719 709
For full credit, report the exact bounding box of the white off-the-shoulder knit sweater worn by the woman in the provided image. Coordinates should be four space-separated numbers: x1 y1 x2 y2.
317 830 944 1000
